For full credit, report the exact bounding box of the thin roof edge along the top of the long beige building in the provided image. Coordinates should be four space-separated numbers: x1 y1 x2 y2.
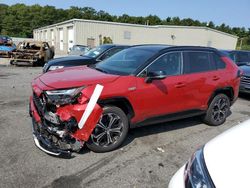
34 19 238 38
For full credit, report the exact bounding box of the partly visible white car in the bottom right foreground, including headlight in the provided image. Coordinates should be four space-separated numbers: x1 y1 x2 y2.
168 120 250 188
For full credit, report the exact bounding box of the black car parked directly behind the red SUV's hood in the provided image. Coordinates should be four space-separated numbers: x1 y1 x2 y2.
43 44 129 73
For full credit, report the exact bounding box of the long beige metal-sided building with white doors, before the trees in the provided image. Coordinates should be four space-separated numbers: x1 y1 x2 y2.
33 19 238 54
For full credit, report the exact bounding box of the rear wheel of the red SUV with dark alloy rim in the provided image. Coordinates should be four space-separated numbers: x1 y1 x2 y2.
203 94 230 126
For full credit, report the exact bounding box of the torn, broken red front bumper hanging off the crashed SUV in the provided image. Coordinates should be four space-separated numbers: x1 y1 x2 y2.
29 96 102 157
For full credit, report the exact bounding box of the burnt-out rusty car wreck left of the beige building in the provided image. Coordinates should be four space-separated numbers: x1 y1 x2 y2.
10 41 54 66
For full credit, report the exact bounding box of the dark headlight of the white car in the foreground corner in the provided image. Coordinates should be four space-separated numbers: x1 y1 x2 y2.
184 148 215 188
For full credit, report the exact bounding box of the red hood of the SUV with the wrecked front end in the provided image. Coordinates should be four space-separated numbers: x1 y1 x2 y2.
39 66 119 89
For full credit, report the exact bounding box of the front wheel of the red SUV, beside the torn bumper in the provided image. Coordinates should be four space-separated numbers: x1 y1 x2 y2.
86 106 129 153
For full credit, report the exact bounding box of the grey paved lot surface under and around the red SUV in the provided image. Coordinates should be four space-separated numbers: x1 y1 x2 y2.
0 65 250 188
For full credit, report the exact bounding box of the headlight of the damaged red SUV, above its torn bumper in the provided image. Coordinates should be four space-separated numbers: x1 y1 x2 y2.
45 86 85 105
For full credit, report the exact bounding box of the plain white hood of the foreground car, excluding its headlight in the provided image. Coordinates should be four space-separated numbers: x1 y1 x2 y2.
204 120 250 188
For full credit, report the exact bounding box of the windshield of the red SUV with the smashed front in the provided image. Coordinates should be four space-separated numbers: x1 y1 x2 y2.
95 48 155 75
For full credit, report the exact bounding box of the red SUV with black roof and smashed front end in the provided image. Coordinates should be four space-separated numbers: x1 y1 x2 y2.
30 45 240 155
